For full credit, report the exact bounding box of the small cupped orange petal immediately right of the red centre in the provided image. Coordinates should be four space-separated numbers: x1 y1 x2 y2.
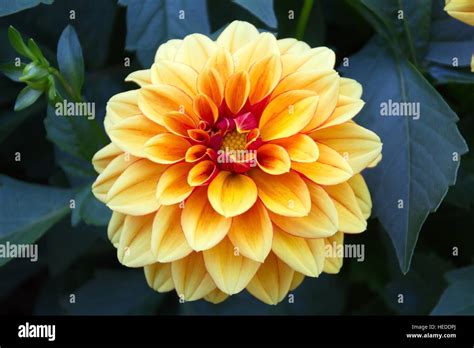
257 144 291 175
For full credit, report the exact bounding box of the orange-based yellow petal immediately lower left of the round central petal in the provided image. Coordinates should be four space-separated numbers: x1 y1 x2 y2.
181 187 232 251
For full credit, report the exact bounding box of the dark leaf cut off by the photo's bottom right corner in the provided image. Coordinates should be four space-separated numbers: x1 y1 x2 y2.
431 266 474 315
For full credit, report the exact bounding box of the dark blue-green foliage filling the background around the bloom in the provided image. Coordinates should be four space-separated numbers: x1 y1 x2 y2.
0 0 474 315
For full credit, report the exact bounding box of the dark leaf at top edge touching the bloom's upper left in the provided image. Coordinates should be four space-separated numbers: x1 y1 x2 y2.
119 0 210 67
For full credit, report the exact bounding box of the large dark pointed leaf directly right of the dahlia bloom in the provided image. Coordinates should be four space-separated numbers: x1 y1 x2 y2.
341 39 467 272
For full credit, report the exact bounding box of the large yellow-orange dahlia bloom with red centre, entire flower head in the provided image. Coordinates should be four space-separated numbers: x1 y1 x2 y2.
93 21 382 304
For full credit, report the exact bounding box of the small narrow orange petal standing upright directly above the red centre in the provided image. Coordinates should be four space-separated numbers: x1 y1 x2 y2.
225 70 250 114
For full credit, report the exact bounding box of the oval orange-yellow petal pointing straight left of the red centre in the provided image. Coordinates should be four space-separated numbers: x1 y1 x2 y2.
145 133 191 164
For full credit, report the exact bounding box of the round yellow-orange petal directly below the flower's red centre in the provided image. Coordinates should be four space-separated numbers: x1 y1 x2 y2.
207 171 257 217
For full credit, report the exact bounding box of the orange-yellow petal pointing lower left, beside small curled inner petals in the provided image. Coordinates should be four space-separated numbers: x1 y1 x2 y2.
156 162 193 205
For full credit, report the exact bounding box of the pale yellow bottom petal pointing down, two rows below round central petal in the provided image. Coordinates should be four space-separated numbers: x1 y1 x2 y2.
203 238 260 295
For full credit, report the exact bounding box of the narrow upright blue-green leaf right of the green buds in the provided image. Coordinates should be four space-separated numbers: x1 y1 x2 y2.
57 25 84 96
